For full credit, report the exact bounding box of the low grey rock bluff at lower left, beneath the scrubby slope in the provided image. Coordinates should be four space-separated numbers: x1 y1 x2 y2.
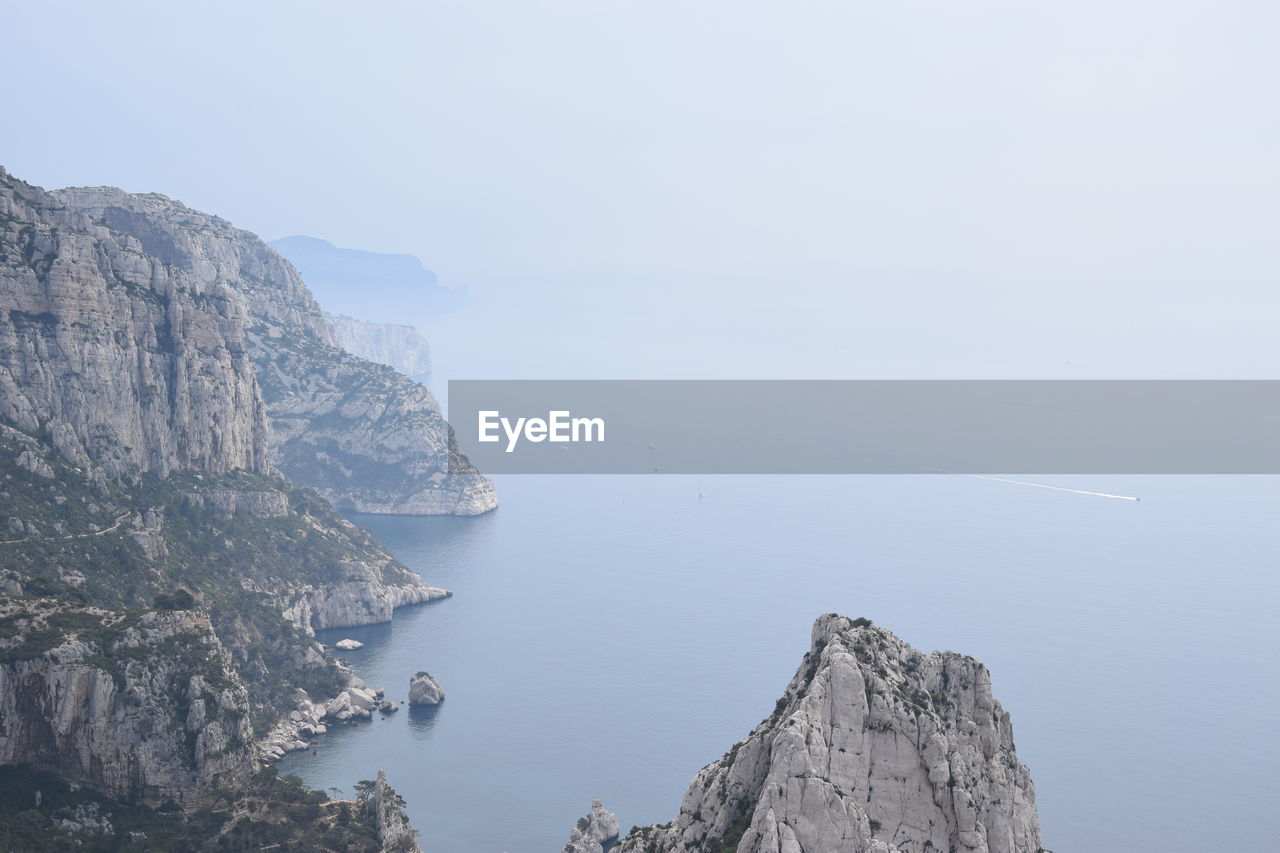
0 603 255 807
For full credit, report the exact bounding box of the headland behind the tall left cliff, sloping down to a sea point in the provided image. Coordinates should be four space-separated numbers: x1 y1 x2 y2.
54 187 497 515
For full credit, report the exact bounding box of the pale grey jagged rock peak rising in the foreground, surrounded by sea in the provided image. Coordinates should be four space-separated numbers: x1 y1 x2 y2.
614 613 1041 853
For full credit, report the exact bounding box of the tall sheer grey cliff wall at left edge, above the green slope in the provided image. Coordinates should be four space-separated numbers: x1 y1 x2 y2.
0 162 268 475
